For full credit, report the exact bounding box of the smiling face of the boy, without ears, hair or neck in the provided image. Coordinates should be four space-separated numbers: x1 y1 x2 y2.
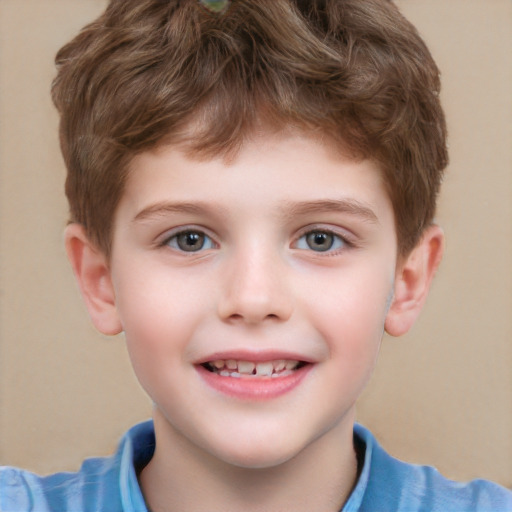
107 131 397 467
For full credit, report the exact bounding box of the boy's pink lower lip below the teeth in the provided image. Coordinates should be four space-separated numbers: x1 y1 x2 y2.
196 364 313 400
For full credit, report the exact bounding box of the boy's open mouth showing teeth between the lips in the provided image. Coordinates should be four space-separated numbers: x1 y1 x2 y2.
201 359 308 379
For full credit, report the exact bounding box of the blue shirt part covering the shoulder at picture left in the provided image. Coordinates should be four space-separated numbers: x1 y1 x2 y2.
0 422 154 512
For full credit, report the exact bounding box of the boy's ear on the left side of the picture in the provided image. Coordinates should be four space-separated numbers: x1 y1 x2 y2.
64 224 123 334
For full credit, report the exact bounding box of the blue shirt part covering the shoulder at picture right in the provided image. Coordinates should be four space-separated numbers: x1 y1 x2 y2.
355 426 512 512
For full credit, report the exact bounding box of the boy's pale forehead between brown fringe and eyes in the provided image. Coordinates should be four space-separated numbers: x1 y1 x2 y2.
120 132 392 228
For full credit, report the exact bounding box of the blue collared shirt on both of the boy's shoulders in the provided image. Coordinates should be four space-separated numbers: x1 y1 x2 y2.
0 421 512 512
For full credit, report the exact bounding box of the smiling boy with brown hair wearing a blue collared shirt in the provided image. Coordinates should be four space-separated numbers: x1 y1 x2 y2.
0 0 512 511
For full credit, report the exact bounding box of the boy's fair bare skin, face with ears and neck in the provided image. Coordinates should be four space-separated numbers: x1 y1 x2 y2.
66 132 443 512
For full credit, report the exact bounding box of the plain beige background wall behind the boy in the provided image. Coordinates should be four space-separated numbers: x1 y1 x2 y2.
0 0 512 486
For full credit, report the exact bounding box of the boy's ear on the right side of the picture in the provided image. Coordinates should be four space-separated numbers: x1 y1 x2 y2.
385 225 444 336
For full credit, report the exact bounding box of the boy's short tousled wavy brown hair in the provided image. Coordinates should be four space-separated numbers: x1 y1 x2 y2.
52 0 447 254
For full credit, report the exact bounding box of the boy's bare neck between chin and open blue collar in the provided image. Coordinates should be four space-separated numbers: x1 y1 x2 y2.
140 410 357 512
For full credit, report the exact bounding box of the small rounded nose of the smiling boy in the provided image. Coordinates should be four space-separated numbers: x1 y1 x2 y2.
218 248 293 324
